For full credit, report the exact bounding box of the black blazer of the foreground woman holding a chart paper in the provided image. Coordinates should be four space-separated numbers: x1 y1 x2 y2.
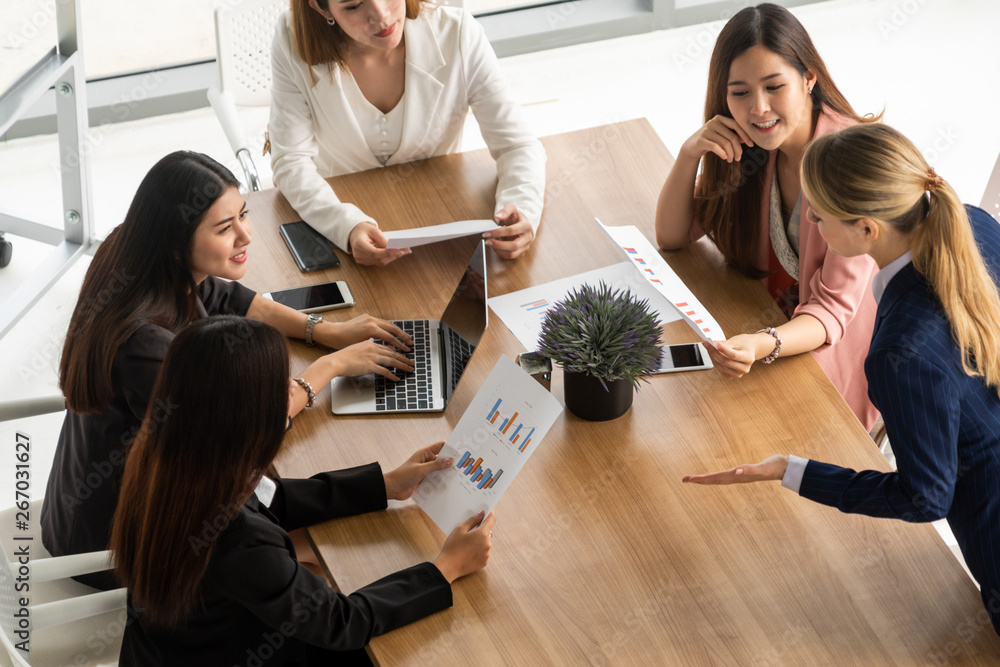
119 463 451 667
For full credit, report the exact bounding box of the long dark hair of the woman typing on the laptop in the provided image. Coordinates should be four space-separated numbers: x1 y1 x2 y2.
59 151 239 414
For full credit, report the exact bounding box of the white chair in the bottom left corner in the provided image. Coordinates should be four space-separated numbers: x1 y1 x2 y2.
0 501 126 667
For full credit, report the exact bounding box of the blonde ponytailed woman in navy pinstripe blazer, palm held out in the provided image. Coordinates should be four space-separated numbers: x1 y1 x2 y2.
684 125 1000 633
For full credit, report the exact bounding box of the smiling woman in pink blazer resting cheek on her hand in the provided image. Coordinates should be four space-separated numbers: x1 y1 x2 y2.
656 3 878 429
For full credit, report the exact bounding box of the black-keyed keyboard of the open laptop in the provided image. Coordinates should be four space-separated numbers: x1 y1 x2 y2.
375 320 434 412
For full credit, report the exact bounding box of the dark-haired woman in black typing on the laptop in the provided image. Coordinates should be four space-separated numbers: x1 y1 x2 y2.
42 151 412 588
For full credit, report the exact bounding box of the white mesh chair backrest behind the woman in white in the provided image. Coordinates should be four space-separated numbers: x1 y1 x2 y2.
215 0 288 106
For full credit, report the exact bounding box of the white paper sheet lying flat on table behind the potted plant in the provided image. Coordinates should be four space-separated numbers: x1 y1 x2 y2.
487 262 681 352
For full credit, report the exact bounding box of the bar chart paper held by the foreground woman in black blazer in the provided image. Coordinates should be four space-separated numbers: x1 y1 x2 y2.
413 356 562 533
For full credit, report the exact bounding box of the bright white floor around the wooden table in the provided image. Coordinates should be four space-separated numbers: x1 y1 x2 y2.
0 0 1000 576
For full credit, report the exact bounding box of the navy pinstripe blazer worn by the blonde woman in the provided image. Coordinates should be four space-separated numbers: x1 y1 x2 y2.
799 206 1000 633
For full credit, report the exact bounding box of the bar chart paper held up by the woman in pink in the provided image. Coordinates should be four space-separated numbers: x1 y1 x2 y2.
594 218 726 343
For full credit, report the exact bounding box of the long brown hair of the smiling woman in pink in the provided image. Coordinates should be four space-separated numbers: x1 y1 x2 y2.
694 3 872 278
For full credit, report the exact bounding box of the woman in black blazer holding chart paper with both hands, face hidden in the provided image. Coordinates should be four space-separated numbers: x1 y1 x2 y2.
111 316 495 667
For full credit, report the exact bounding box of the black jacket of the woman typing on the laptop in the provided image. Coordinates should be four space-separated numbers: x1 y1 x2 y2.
42 276 255 589
